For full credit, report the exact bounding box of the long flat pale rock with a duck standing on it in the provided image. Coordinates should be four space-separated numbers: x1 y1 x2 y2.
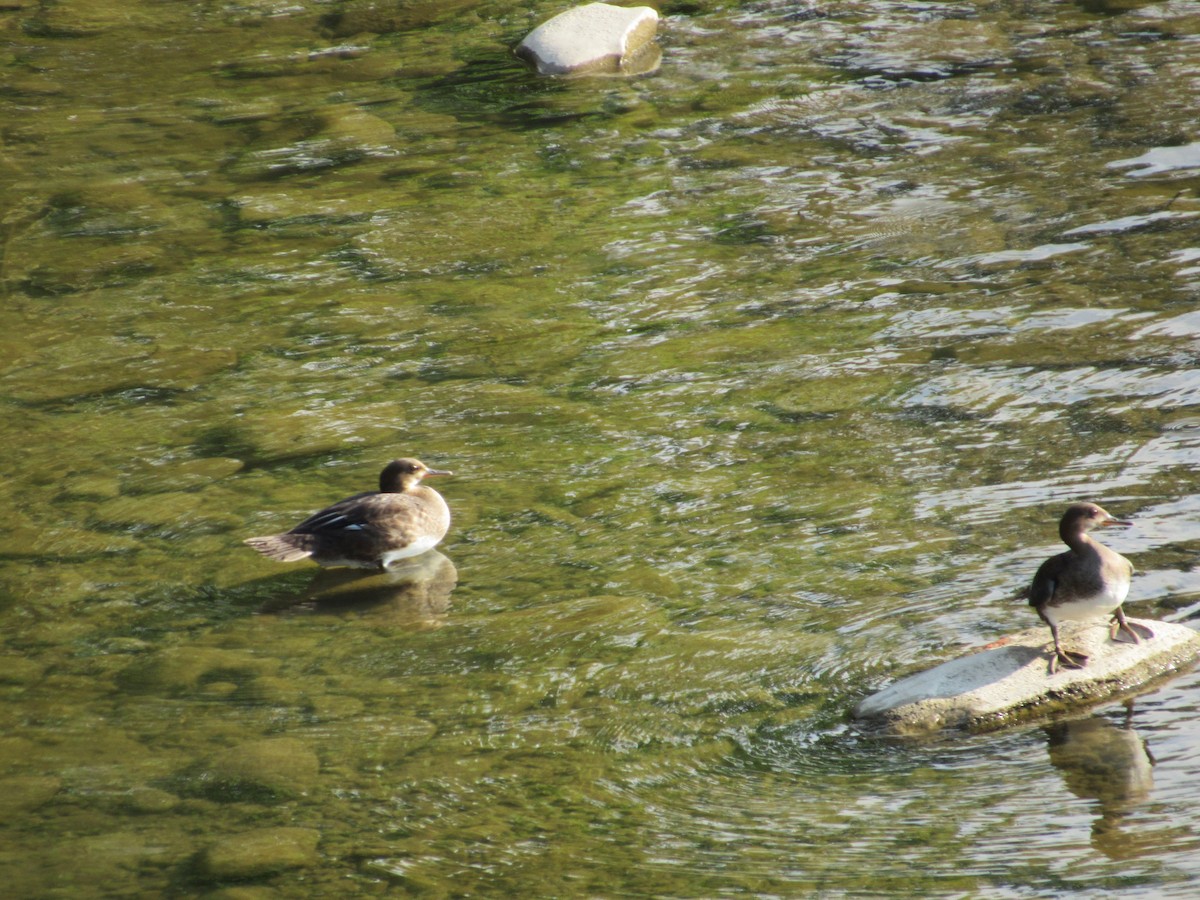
854 619 1200 736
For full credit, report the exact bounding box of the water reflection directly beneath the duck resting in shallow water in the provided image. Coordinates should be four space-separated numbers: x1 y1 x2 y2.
260 550 458 630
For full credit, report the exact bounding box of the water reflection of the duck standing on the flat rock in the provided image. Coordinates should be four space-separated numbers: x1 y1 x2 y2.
1045 703 1162 859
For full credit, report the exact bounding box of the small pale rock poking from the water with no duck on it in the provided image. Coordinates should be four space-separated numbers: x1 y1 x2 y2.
516 4 662 74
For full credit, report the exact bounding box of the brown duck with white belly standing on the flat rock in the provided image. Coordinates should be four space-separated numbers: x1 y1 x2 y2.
1030 503 1154 674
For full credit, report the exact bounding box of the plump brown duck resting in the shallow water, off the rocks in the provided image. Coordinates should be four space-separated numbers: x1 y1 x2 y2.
245 460 454 569
